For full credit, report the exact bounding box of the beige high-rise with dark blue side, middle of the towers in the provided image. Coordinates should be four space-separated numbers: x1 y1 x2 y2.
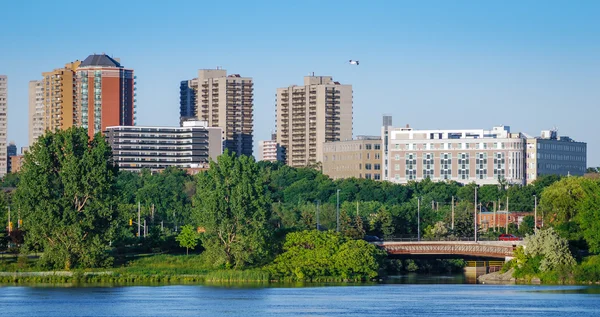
180 69 254 156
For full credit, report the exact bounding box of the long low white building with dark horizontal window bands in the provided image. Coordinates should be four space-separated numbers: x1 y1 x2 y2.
105 121 223 172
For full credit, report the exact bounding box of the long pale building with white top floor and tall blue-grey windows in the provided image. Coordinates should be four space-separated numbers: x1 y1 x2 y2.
382 119 526 185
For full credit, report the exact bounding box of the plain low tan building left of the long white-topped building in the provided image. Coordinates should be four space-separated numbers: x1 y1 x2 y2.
322 136 382 180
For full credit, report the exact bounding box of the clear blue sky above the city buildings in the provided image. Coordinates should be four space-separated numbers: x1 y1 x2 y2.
0 0 600 166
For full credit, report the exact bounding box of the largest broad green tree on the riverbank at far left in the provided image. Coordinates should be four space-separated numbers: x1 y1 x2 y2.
16 128 118 270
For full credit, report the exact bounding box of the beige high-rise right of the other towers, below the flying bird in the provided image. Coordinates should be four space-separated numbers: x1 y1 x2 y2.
276 76 352 167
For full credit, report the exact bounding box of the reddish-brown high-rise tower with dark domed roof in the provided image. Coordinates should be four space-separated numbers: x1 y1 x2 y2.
75 54 136 136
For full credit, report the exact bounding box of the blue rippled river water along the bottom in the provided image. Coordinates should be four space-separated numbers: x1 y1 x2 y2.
0 277 600 317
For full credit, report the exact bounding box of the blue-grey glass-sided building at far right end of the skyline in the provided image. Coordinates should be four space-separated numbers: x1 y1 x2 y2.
525 130 587 183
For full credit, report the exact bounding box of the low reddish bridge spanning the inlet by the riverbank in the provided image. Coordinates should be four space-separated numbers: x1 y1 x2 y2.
375 241 523 260
